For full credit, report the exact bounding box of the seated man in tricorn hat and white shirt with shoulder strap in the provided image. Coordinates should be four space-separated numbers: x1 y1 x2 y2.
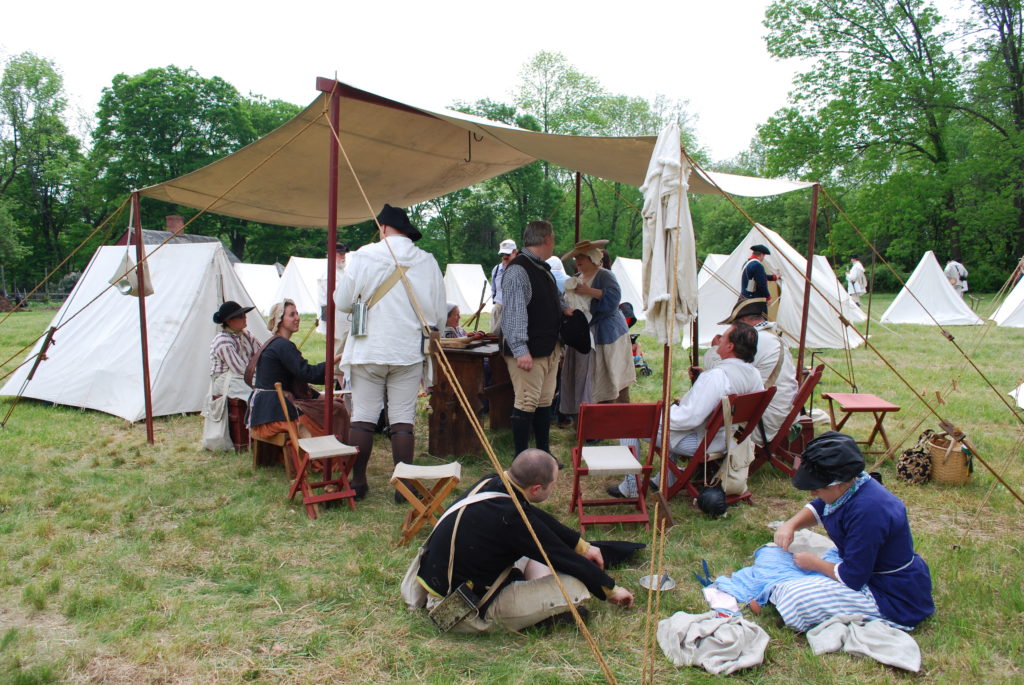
690 297 797 445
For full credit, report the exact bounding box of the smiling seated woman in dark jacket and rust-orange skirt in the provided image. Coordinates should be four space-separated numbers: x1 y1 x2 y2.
249 300 348 442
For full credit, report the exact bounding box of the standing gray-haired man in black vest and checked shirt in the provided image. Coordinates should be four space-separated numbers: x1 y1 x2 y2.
502 221 563 455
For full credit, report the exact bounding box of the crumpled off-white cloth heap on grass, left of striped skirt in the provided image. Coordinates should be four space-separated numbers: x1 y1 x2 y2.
657 611 768 675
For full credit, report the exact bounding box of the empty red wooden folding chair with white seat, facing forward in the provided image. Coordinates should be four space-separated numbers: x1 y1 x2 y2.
569 402 662 533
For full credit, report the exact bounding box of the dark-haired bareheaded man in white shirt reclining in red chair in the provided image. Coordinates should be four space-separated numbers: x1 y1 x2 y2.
608 322 765 497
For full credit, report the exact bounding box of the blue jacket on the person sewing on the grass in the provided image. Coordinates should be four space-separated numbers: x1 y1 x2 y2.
811 478 935 627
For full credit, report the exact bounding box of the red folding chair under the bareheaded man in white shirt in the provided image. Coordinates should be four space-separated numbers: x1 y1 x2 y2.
662 387 775 504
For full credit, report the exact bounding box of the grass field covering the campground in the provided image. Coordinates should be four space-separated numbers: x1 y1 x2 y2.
0 296 1024 683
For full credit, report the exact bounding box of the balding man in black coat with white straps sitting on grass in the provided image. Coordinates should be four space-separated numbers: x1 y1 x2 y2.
417 449 633 633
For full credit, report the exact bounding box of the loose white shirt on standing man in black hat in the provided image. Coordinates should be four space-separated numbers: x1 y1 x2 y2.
335 236 447 367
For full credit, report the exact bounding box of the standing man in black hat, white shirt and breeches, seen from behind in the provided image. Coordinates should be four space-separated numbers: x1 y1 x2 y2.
335 205 447 502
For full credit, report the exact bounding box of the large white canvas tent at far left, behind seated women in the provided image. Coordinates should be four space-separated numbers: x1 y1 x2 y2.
0 243 270 422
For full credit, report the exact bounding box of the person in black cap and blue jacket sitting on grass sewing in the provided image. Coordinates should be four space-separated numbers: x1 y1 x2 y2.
769 431 935 632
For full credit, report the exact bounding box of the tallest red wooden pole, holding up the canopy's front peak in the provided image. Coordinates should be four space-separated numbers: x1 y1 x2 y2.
316 79 341 435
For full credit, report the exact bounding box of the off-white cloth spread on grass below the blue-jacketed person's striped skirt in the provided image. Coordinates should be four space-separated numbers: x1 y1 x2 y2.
807 615 921 673
